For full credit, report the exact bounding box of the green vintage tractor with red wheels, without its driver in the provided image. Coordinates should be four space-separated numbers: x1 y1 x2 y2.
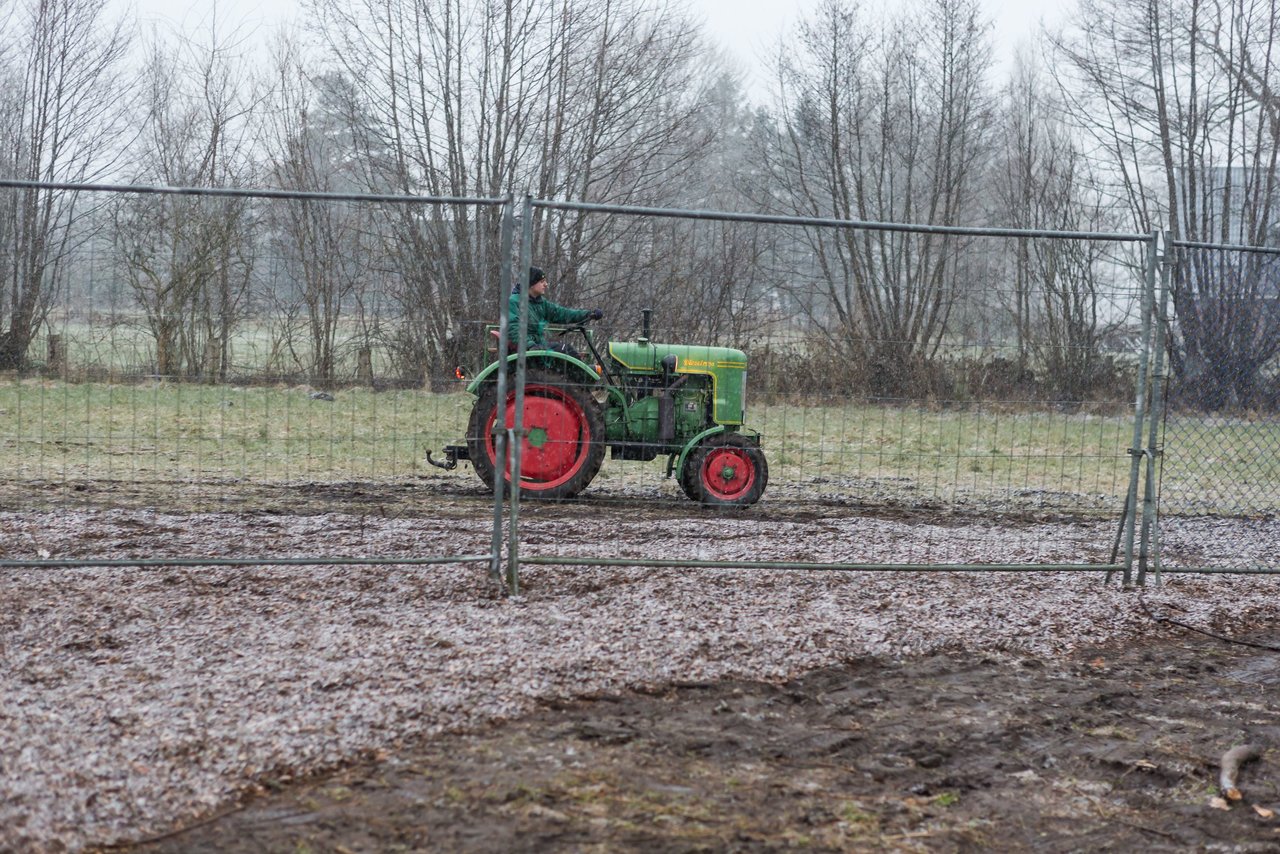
426 311 769 507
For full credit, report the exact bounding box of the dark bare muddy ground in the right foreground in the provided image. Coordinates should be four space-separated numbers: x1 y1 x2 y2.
119 625 1280 853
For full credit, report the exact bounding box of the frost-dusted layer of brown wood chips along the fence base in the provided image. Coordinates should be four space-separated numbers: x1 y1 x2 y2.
0 504 1280 850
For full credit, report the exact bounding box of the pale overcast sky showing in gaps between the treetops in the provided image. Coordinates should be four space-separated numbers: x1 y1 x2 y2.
129 0 1074 92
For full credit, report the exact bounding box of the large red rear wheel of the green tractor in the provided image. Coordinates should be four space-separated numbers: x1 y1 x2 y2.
467 370 604 498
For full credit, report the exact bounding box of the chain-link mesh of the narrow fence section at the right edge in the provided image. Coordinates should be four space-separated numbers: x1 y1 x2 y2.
1153 241 1280 570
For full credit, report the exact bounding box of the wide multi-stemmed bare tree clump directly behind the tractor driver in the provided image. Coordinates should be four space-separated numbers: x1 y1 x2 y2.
302 0 721 381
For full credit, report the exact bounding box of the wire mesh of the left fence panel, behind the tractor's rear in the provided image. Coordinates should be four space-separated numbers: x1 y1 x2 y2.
0 182 503 578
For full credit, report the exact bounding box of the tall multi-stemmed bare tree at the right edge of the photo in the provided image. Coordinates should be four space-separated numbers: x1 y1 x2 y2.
1060 0 1280 410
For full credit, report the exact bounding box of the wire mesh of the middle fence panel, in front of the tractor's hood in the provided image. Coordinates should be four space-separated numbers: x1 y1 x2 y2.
472 202 1147 588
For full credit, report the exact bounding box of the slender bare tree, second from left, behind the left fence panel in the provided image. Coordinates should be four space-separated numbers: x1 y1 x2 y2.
115 21 256 378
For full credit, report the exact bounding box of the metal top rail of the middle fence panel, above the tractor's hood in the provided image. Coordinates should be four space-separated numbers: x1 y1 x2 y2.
530 198 1152 243
